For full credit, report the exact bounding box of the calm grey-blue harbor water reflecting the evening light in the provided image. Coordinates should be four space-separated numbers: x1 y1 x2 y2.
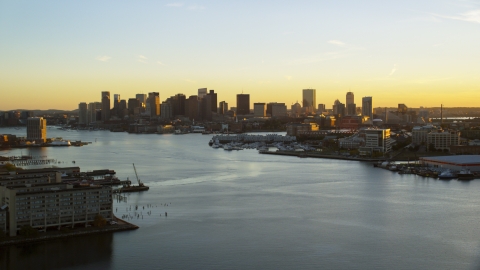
0 129 480 269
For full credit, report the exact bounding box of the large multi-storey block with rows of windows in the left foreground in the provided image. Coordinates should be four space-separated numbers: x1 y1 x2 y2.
0 183 113 236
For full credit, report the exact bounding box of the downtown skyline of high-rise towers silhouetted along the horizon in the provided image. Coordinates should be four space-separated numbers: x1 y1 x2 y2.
78 88 373 125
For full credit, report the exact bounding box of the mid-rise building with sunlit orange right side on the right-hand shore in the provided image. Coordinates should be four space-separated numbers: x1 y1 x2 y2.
359 128 392 156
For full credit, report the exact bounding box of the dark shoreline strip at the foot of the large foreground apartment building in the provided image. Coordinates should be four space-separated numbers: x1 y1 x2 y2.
0 217 140 247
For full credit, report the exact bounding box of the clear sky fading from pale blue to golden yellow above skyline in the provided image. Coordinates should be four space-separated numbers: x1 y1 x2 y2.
0 0 480 111
